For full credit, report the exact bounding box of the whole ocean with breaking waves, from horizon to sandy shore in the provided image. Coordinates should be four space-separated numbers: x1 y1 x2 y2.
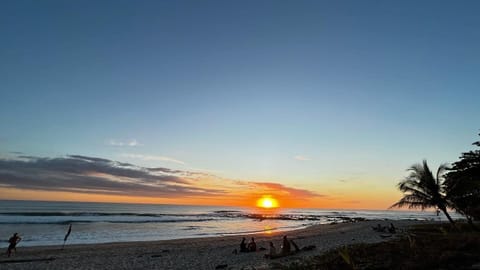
0 200 461 247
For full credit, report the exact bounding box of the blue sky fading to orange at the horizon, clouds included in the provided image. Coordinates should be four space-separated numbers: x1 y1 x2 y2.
0 0 480 209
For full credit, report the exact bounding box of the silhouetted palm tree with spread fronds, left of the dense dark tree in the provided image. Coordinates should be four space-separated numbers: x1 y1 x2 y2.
390 160 455 224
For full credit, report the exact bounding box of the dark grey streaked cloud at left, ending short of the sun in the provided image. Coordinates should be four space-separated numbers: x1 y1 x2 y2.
0 155 220 197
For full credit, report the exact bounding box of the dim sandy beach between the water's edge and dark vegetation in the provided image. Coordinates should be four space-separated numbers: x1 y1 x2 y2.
0 221 428 270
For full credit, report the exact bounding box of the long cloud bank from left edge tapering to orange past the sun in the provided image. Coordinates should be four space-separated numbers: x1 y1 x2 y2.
0 155 324 202
